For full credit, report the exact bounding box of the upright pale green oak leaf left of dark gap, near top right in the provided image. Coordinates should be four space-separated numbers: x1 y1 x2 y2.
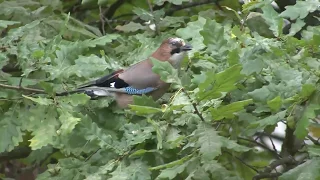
261 4 283 37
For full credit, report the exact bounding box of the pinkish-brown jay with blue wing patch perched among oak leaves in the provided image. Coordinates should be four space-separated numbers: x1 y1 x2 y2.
57 38 192 108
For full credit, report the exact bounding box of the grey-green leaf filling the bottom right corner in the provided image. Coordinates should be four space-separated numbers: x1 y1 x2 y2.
279 159 320 180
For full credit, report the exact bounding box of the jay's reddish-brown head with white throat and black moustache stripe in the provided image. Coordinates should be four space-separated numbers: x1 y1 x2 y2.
153 37 192 68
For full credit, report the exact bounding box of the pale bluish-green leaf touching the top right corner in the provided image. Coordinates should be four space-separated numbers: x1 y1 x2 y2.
280 1 320 20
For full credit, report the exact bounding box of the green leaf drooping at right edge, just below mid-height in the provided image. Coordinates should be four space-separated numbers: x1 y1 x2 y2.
294 104 320 139
